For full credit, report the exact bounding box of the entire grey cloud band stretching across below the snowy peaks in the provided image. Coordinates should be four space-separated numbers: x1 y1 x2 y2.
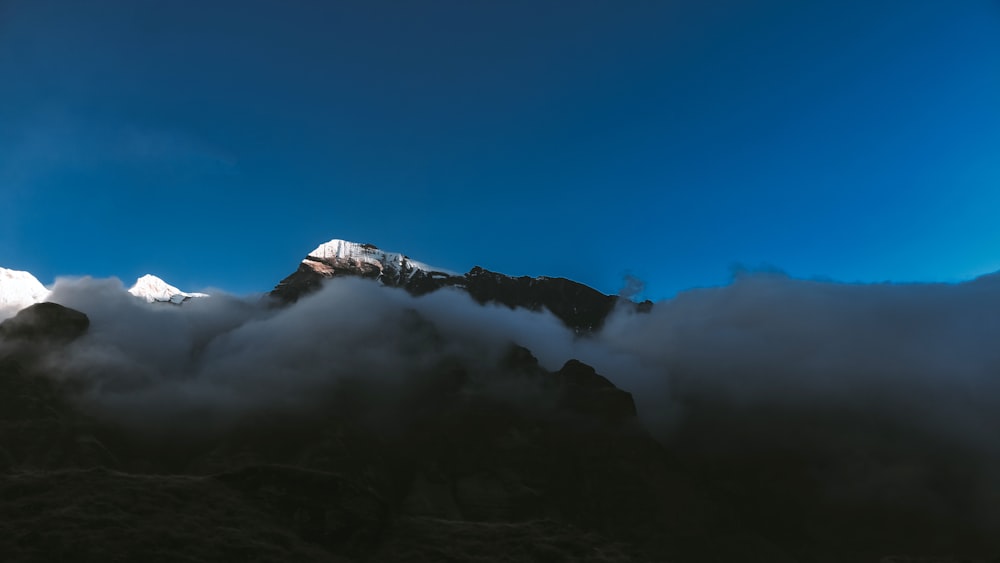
41 274 1000 448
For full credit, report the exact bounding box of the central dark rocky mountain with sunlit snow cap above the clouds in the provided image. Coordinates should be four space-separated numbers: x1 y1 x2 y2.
271 239 652 333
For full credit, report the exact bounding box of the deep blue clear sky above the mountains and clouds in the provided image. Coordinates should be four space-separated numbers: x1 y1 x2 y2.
0 0 1000 299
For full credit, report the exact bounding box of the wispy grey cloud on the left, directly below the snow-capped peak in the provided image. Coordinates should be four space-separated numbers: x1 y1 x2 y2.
43 278 573 428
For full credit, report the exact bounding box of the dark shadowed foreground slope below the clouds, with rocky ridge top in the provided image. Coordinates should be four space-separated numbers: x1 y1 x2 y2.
0 306 1000 563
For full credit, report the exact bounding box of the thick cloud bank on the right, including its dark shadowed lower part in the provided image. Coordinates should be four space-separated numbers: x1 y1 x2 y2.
594 273 1000 529
